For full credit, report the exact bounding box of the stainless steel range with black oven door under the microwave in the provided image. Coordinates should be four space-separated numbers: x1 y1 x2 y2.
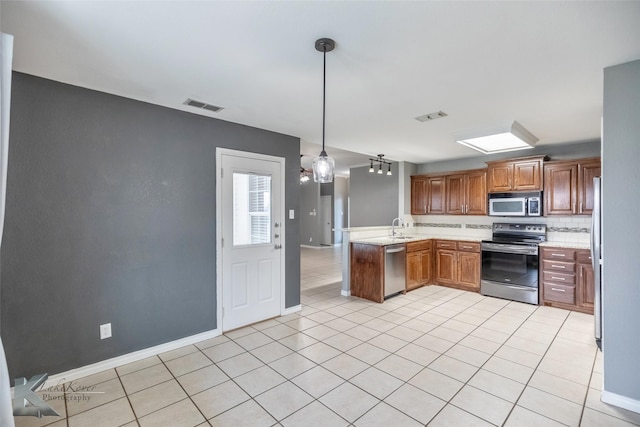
480 223 547 305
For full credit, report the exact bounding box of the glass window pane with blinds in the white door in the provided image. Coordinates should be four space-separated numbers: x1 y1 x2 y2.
233 172 271 246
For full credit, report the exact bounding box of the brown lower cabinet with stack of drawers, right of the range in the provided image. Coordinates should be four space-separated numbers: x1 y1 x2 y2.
540 247 595 314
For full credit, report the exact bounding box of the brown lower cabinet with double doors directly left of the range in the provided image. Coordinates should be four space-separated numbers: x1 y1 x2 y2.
434 240 480 292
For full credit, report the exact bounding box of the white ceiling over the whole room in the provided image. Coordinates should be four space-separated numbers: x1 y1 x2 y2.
1 0 640 176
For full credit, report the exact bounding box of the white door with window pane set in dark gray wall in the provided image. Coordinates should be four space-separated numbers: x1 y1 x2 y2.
218 149 284 331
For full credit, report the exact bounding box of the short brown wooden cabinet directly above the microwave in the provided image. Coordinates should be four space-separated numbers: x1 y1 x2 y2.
487 156 547 193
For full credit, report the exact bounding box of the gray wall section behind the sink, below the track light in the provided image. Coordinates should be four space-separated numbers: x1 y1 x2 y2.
349 162 401 227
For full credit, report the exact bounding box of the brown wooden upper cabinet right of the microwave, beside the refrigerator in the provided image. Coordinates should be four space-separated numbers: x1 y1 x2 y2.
544 157 601 215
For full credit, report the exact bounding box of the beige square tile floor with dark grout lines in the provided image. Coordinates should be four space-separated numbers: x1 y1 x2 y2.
16 248 640 427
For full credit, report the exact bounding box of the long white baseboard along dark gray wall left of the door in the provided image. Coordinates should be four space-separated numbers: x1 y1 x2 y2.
42 329 222 388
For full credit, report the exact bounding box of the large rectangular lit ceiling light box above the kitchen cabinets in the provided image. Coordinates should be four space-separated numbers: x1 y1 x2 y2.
456 121 538 154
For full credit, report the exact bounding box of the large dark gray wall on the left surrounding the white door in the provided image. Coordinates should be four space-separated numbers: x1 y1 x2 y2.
0 73 300 378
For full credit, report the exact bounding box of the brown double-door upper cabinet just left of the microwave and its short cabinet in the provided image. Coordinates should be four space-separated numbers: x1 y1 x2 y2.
445 169 487 215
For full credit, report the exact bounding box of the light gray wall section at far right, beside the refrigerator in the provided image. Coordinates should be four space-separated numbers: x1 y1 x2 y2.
602 60 640 404
